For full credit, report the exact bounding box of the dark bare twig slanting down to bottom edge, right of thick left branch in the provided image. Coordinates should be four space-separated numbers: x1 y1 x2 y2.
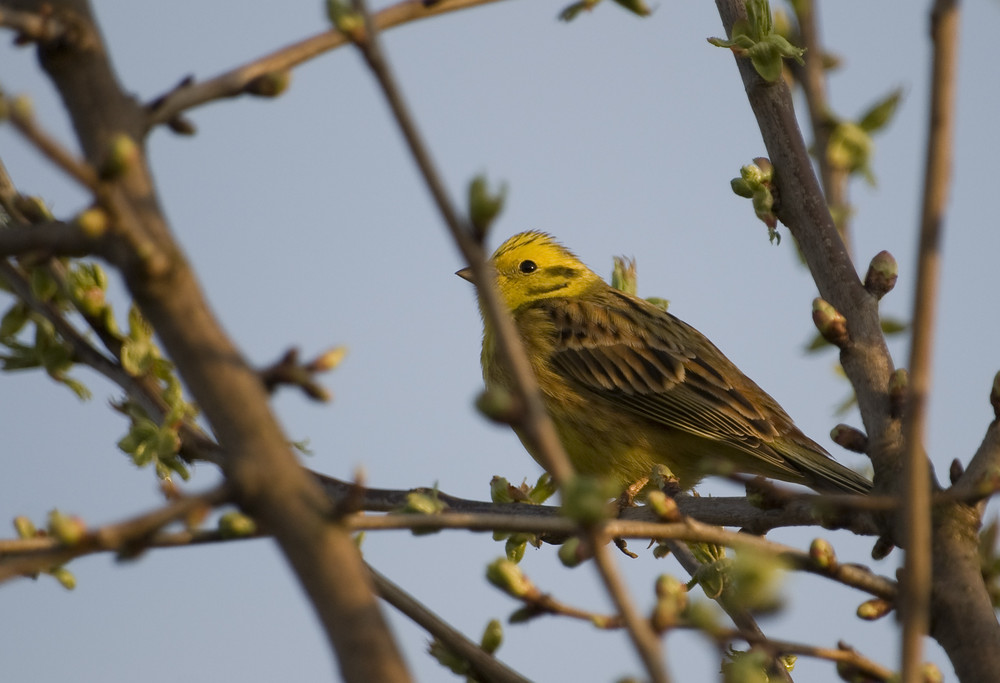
368 565 540 683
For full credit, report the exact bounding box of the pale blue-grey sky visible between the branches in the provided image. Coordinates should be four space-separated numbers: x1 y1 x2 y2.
0 0 1000 683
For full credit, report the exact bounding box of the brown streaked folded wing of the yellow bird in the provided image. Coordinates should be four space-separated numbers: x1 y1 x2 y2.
549 293 791 476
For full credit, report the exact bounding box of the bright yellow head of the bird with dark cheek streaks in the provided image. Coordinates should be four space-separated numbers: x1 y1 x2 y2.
459 232 604 311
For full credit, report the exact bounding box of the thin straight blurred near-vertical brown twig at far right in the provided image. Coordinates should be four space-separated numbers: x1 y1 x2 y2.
900 0 958 683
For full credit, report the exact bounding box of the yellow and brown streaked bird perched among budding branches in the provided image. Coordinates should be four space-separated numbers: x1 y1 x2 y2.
458 232 871 493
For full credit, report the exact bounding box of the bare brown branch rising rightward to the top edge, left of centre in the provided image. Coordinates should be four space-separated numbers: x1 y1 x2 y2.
146 0 508 128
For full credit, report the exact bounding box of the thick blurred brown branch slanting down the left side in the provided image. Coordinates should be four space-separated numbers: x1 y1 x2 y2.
5 0 409 681
